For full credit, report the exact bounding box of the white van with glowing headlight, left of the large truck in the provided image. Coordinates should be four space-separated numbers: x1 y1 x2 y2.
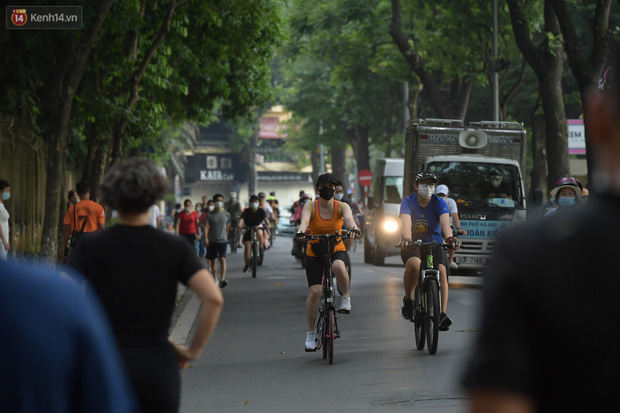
364 158 405 265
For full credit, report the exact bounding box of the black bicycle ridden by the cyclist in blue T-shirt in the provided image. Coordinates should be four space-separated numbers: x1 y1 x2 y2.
396 240 451 354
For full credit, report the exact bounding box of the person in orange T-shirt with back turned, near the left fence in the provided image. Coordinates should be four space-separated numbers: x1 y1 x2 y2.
62 181 105 261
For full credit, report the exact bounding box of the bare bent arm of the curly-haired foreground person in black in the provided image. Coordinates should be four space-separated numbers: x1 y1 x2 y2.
170 269 224 368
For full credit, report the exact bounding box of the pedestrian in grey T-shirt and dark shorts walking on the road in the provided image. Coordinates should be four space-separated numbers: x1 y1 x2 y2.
205 194 230 288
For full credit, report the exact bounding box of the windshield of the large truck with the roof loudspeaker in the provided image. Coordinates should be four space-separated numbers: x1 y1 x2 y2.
428 162 523 208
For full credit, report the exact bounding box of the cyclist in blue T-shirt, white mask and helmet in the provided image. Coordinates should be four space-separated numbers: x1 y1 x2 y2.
400 171 458 331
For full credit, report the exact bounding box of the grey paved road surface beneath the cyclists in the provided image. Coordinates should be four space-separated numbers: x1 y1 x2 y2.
175 238 480 413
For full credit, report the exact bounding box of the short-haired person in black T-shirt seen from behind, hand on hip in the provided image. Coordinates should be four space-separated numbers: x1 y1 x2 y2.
69 159 223 413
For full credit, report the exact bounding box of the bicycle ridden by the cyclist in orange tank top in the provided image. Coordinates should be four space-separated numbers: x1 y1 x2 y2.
303 230 349 364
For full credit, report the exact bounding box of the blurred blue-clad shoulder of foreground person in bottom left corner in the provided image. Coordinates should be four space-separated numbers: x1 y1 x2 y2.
0 260 138 413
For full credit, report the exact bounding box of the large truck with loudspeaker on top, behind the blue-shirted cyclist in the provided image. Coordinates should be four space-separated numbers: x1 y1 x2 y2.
403 119 527 270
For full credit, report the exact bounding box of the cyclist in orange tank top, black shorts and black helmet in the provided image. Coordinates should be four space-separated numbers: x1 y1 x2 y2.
298 174 360 351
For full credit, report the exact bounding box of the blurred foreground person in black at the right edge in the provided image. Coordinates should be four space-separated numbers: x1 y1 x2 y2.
464 45 620 413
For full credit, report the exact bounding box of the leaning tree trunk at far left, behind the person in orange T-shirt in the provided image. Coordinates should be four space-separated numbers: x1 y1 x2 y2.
41 0 114 262
